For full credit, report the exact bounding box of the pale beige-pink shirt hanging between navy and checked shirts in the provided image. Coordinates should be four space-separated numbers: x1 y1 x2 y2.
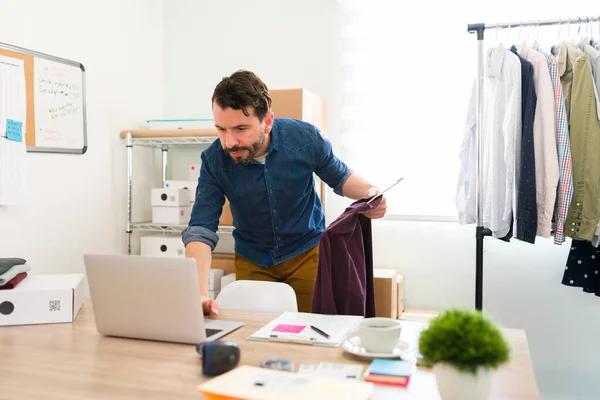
518 43 558 238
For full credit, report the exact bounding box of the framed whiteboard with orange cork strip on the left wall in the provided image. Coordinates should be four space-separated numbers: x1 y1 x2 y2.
0 43 87 154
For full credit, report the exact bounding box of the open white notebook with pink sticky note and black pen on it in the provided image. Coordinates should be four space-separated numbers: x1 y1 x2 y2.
248 311 364 347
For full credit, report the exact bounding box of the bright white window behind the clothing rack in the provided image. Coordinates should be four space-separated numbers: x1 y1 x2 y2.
338 0 600 220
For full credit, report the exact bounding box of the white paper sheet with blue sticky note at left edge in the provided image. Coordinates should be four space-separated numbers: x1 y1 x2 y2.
0 56 27 205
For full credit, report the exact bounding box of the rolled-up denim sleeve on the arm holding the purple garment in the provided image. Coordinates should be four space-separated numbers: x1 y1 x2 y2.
315 128 353 196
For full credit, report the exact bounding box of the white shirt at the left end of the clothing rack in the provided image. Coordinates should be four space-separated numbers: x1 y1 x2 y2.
456 45 521 238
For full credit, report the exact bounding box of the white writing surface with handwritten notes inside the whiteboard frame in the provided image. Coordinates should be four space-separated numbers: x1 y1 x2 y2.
34 58 84 149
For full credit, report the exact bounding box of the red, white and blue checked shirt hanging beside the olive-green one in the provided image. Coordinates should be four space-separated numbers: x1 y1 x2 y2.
533 43 573 245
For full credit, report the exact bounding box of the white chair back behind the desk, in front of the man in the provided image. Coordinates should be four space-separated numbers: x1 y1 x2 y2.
215 280 298 312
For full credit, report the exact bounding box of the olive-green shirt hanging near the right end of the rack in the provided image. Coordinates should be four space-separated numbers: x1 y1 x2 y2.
558 43 600 240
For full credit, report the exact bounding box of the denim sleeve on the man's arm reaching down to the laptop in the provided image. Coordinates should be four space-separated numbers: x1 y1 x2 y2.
181 153 225 250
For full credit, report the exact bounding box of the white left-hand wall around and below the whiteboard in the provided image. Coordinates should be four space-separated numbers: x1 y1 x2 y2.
0 0 164 273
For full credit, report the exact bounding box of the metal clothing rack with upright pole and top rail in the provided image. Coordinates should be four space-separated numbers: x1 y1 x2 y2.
467 15 600 311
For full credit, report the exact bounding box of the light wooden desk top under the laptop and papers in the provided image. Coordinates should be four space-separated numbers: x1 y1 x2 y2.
0 303 539 400
